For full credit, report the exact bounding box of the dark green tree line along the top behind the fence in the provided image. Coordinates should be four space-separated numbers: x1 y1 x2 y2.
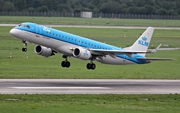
0 0 180 15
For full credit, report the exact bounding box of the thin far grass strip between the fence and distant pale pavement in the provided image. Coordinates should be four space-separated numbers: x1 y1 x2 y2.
0 16 180 27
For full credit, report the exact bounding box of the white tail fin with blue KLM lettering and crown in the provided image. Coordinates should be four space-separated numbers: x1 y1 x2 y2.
127 27 154 56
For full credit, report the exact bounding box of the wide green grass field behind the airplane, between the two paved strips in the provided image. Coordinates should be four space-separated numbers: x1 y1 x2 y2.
0 27 180 79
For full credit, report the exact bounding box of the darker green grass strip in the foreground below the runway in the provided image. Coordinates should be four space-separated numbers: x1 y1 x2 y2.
0 94 180 113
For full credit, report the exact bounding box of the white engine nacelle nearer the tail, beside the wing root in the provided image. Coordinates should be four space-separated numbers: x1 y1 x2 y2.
73 48 92 60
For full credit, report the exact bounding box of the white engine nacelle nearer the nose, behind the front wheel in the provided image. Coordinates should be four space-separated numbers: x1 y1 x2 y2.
34 45 54 57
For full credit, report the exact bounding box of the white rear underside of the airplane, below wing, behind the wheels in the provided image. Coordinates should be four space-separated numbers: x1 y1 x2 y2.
96 55 135 65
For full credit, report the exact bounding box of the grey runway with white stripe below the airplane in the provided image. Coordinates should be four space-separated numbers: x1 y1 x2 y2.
0 79 180 94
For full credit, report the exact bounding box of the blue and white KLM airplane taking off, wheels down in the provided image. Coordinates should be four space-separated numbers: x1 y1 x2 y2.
10 22 172 70
